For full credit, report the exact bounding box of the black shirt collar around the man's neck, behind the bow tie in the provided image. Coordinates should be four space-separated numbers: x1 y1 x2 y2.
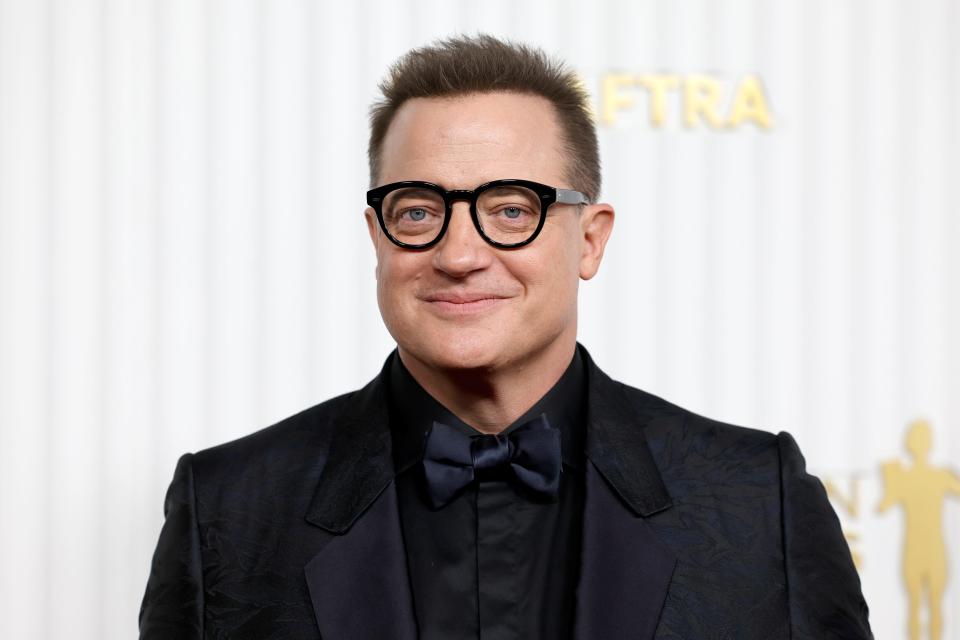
387 345 586 473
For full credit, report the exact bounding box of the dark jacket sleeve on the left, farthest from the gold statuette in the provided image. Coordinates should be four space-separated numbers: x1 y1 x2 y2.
140 453 203 640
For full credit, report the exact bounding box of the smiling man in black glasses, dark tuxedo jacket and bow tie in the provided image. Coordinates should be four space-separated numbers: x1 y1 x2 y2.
140 37 871 640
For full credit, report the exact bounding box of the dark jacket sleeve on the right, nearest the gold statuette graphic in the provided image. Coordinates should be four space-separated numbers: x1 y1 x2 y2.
777 433 873 640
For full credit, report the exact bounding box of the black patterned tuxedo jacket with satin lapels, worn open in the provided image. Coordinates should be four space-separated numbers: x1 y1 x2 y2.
140 350 872 640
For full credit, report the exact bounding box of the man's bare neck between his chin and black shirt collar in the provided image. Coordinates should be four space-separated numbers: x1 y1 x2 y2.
398 335 577 434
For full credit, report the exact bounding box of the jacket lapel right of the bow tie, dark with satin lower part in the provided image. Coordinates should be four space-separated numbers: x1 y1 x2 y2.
575 350 677 640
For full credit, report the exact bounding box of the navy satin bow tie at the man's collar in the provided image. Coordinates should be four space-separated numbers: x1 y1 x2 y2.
423 414 561 509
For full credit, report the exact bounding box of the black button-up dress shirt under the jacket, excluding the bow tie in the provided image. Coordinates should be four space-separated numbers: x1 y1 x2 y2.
389 347 586 640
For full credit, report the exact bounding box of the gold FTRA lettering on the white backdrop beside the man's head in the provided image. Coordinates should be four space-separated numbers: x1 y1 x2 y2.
600 73 772 130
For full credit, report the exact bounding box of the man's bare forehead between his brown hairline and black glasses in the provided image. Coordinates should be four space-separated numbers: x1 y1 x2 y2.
380 93 567 189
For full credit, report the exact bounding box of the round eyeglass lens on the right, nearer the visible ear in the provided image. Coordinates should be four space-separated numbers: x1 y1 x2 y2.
477 185 541 244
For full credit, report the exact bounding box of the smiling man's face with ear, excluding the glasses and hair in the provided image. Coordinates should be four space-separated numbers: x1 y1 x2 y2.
366 93 613 371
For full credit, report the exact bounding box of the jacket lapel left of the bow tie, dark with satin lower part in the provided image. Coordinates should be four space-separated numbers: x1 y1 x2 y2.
304 358 417 640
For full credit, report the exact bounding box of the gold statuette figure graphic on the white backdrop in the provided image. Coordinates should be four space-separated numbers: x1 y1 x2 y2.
877 420 960 640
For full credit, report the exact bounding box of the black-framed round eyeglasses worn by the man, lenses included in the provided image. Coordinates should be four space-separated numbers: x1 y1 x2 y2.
367 179 589 249
